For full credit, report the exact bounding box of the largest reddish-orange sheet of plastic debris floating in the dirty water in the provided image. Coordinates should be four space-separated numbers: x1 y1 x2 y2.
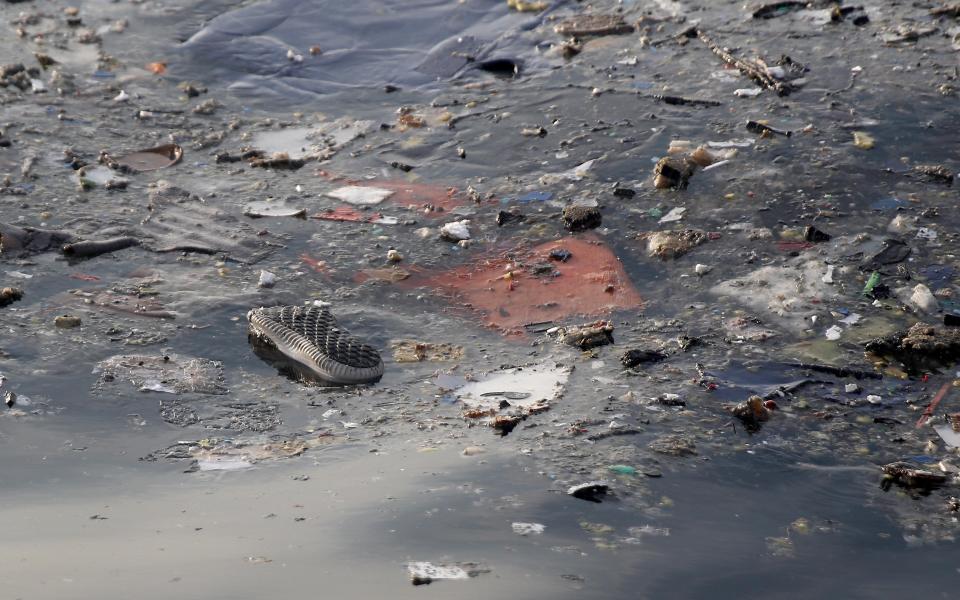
426 237 643 333
